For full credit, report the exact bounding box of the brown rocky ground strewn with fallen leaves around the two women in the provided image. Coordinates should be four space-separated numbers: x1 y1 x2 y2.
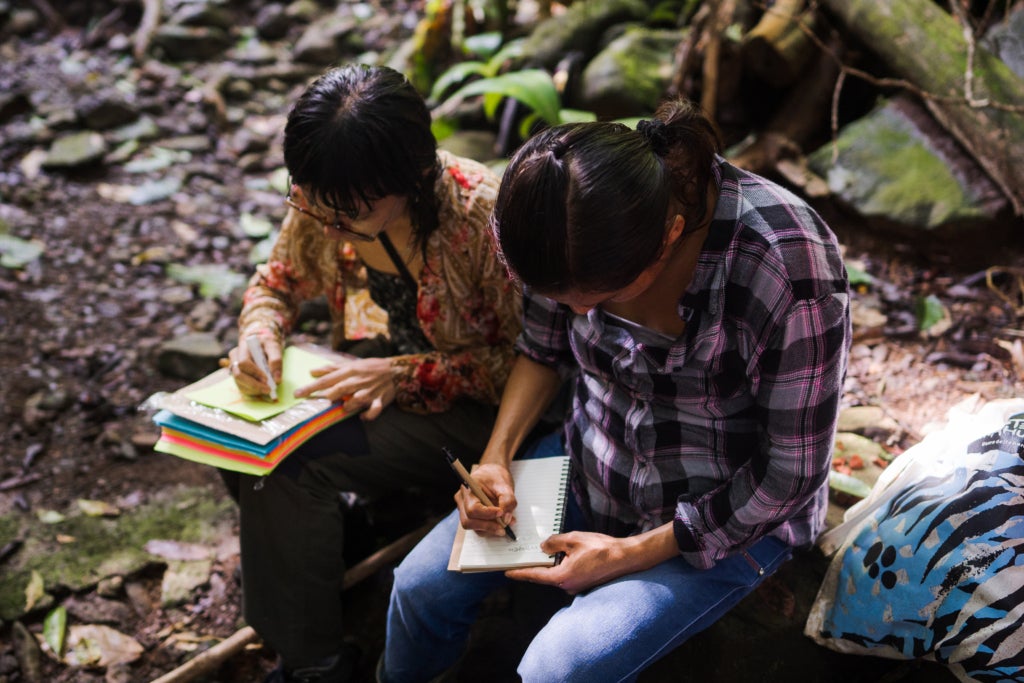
0 1 1024 683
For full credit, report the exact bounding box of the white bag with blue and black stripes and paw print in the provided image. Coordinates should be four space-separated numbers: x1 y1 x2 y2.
805 401 1024 682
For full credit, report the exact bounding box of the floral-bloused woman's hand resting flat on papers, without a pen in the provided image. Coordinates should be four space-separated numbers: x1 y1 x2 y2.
295 358 395 420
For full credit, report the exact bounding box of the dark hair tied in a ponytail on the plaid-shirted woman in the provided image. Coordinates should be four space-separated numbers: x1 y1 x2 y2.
492 100 721 294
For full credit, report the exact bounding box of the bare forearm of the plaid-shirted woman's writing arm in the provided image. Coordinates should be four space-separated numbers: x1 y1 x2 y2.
480 355 562 466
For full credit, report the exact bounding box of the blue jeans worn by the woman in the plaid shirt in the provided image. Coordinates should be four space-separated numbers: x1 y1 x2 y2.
381 456 792 683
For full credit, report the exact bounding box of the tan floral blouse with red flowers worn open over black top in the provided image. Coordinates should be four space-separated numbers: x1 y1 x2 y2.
239 151 521 413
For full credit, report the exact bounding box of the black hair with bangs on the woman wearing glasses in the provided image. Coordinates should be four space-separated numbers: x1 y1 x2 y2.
285 65 439 248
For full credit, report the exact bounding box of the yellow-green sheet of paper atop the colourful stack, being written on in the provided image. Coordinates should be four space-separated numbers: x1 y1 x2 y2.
185 346 331 422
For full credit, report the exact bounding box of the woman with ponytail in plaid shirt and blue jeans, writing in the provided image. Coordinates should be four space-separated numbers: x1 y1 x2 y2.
380 101 850 683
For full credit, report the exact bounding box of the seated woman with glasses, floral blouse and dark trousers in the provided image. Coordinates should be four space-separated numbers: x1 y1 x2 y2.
228 66 521 683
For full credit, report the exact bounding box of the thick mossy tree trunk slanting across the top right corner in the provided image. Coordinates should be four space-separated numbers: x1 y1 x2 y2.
822 0 1024 216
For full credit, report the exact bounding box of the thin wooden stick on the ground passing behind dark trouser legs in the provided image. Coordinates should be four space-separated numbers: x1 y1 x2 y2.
153 519 437 683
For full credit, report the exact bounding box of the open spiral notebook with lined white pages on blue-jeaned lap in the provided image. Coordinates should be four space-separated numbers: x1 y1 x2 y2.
449 456 569 571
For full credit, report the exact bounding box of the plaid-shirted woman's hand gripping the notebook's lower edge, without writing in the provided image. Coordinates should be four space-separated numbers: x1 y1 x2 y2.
505 531 634 595
